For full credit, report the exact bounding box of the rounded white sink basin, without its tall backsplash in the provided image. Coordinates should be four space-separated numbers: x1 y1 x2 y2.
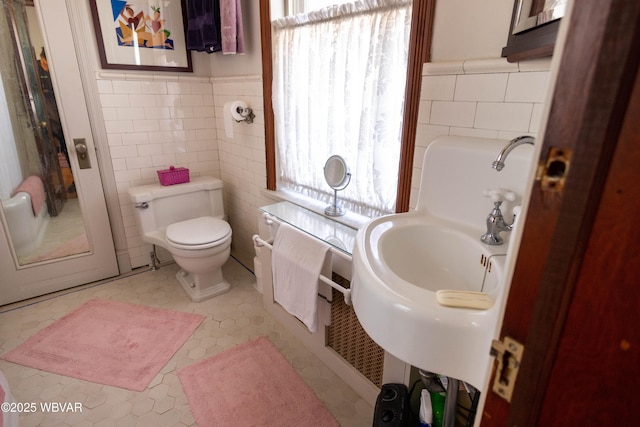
351 213 505 389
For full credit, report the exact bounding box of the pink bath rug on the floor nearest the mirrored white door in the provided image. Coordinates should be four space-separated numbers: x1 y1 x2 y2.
2 299 204 391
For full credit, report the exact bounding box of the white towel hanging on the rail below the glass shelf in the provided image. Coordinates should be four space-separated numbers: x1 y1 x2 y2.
271 223 329 332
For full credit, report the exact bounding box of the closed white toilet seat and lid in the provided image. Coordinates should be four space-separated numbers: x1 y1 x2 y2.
166 216 231 250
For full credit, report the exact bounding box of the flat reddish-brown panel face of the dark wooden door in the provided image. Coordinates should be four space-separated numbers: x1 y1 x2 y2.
539 66 640 426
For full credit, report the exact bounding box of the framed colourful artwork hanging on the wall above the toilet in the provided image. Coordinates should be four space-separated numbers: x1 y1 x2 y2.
89 0 193 72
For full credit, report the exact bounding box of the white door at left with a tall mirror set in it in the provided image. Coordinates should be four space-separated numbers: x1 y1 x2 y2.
0 0 118 305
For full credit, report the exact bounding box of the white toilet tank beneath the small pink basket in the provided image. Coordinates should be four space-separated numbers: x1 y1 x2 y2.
129 176 224 235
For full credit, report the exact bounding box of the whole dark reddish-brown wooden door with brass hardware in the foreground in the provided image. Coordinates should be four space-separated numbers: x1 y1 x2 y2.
482 0 640 426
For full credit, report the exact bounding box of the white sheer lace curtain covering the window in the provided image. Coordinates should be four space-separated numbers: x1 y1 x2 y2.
272 0 411 216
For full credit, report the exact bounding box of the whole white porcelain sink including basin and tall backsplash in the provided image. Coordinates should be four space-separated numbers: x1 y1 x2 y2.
351 137 533 391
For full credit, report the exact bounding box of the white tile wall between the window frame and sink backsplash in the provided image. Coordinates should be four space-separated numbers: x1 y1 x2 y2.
409 60 549 208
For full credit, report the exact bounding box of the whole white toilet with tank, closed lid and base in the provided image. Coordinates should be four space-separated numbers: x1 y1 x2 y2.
129 176 231 302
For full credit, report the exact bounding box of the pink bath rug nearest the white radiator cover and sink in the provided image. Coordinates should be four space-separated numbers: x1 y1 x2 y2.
178 337 338 427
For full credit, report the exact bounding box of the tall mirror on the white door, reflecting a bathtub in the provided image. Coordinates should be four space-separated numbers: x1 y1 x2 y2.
0 0 89 265
